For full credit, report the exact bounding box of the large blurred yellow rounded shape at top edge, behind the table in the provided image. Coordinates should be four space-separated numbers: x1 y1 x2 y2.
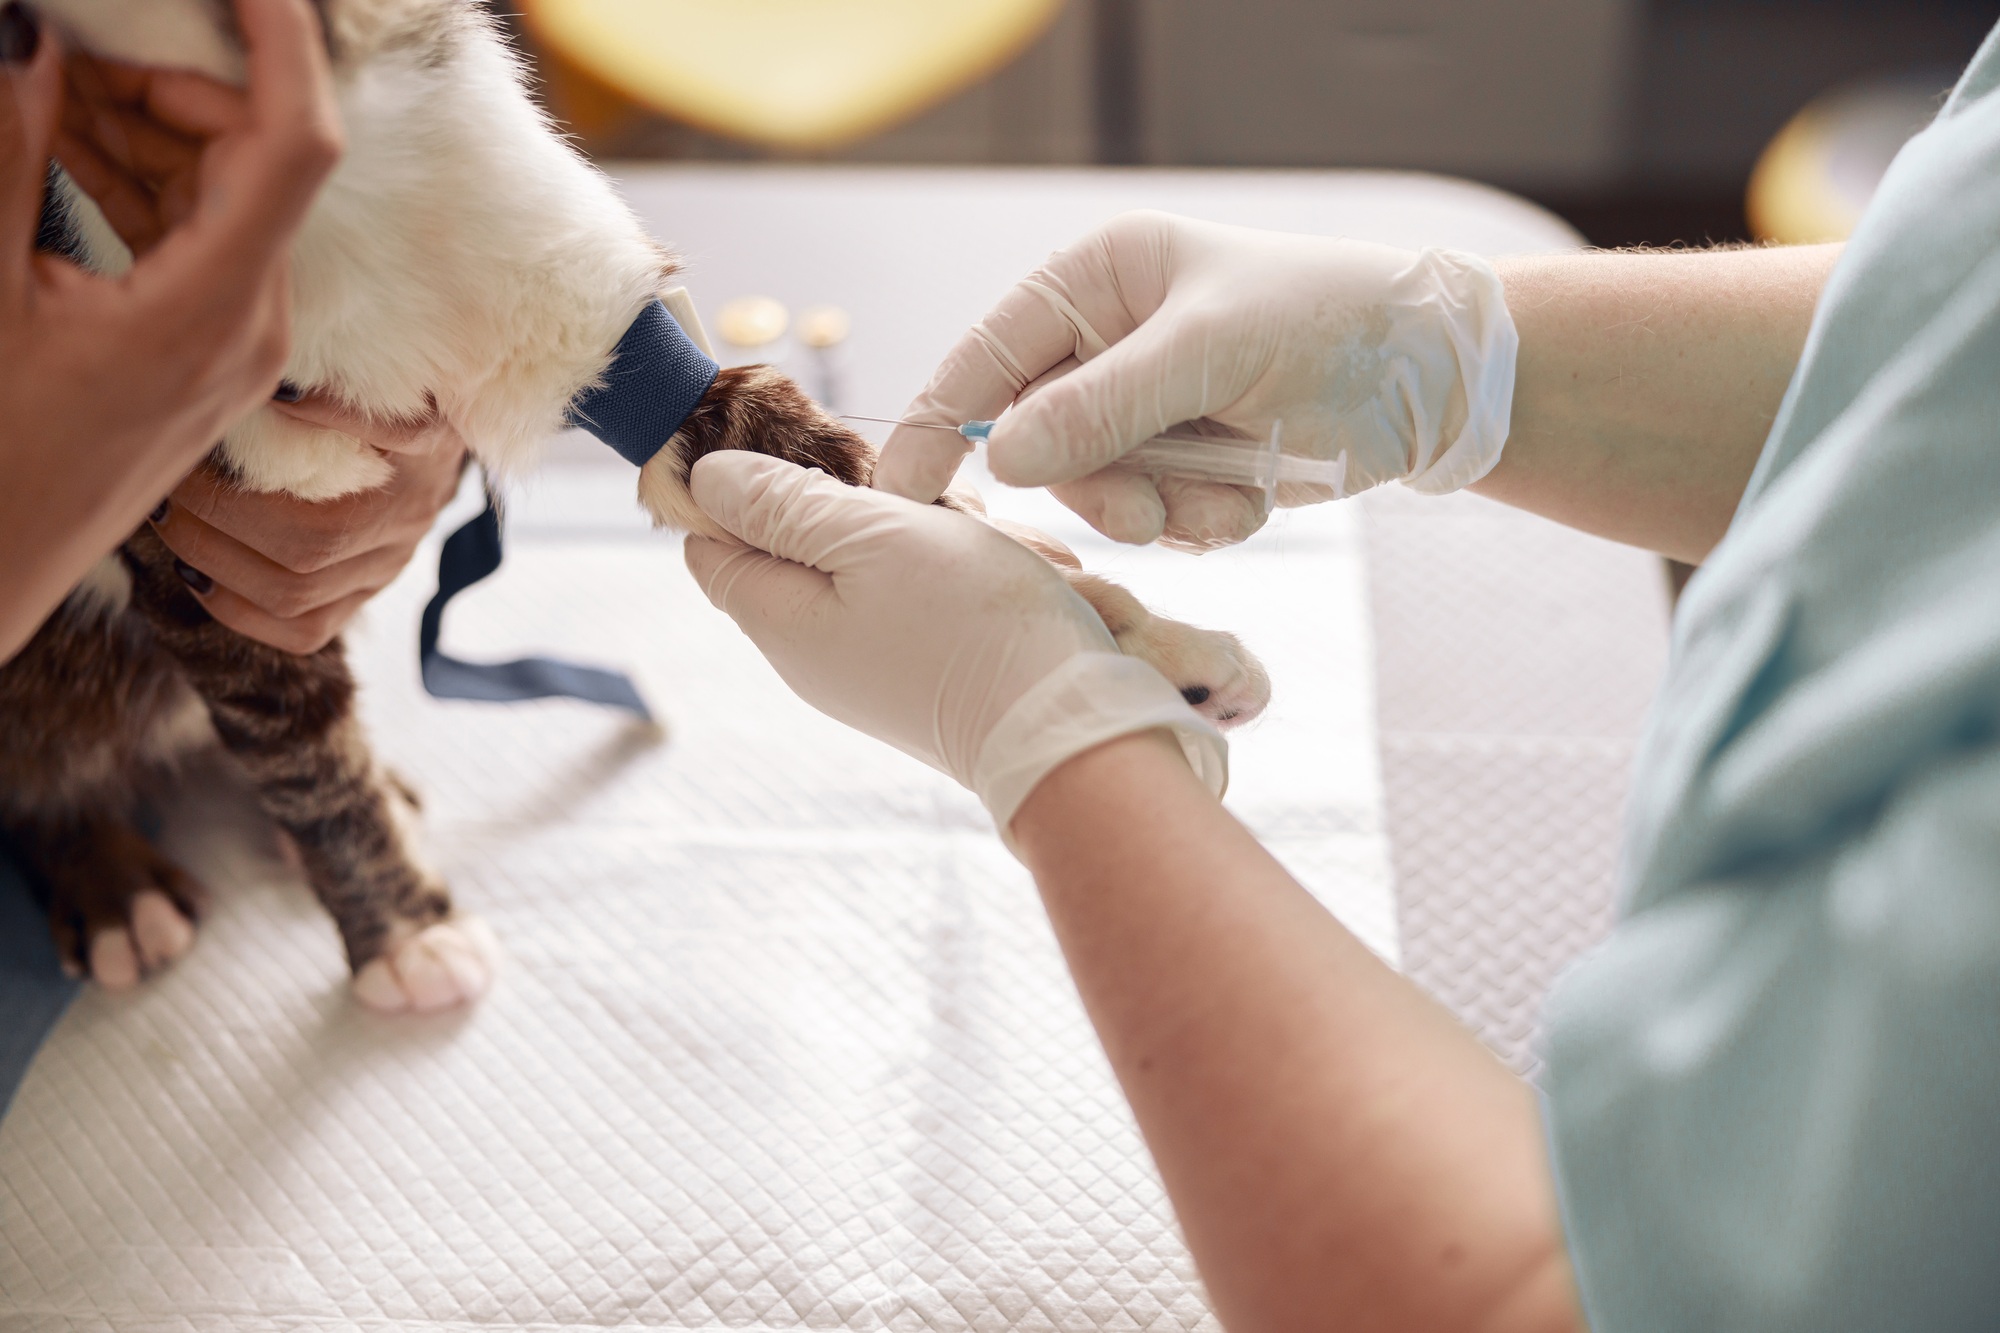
524 0 1062 148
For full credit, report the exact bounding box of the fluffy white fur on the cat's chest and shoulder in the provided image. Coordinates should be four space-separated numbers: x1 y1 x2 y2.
36 0 668 500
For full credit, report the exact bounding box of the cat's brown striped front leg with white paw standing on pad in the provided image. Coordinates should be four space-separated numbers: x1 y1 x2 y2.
126 528 492 1011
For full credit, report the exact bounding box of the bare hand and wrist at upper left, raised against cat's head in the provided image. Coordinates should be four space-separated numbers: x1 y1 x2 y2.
0 0 342 654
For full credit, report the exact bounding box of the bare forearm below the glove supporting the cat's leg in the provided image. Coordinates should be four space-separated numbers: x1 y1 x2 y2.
1014 733 1576 1333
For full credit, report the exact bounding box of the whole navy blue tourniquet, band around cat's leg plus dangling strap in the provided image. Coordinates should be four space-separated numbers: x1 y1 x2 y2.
416 300 718 721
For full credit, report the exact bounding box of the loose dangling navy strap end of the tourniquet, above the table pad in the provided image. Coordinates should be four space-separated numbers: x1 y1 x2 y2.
416 492 652 721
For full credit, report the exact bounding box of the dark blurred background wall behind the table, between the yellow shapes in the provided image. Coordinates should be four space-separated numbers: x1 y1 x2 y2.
512 0 2000 244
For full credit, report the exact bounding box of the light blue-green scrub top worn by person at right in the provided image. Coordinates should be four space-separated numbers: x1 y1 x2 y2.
1544 30 2000 1333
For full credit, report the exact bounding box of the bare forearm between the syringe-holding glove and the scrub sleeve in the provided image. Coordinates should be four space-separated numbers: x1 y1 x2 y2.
1474 246 1840 562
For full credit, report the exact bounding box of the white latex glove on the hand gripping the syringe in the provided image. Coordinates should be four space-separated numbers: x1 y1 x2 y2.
874 212 1518 550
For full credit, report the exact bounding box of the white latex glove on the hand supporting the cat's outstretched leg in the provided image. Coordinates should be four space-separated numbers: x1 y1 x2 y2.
686 450 1228 847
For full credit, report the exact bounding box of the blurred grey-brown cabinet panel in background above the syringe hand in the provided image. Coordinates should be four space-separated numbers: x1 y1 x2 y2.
1136 0 1638 186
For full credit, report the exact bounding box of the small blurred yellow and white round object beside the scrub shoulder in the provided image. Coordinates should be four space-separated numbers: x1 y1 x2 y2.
1744 74 1948 244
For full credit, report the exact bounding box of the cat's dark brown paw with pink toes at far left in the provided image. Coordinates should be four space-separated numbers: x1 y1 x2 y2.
4 807 204 991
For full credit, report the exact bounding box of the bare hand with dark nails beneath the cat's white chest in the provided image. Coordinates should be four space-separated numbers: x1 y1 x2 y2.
152 394 466 652
